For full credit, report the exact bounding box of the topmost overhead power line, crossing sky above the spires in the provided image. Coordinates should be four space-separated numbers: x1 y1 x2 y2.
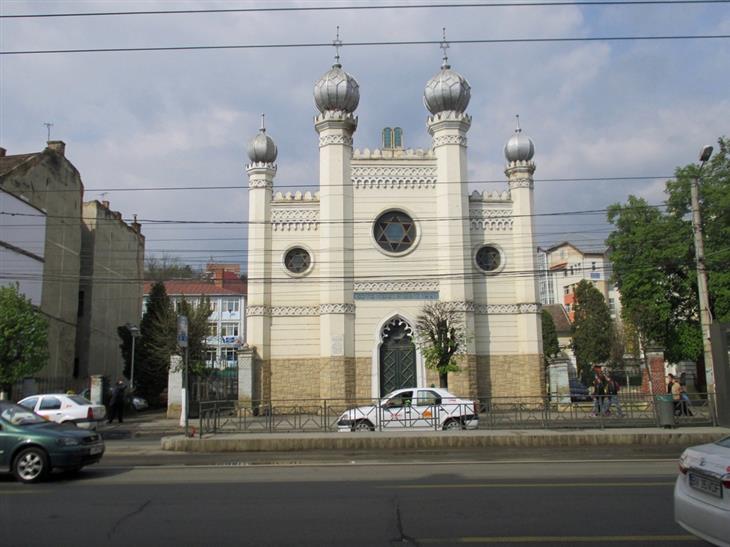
0 0 730 19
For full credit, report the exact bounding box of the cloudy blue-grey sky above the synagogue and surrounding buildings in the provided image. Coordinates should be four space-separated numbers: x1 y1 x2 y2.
0 0 730 274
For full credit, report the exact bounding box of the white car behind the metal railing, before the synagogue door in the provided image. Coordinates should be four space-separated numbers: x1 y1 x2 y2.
337 387 479 431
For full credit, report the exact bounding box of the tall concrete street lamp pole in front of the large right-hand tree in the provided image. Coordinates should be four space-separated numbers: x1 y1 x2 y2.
691 145 715 391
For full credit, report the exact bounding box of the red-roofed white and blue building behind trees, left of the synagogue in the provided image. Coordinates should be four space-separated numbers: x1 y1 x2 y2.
144 264 247 368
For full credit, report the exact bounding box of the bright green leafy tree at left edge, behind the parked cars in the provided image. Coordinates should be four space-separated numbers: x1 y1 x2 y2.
0 285 48 399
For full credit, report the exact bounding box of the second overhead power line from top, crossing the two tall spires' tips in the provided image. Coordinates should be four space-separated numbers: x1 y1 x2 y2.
0 34 730 55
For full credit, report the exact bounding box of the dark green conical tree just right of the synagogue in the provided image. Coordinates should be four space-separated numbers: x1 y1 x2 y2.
570 279 612 381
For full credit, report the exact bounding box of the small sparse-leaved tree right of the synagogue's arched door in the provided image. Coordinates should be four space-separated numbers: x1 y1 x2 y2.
416 302 466 389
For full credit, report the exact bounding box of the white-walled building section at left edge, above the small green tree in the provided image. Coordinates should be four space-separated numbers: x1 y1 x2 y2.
0 190 46 306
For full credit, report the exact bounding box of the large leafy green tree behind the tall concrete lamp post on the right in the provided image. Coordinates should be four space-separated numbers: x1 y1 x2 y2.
608 138 730 372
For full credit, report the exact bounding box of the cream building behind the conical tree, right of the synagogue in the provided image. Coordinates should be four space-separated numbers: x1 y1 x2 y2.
537 241 621 321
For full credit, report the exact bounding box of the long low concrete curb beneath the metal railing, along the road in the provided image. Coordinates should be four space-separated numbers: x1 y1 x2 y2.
160 428 730 452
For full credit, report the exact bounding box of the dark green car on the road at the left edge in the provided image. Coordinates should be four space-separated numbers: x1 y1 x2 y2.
0 401 104 483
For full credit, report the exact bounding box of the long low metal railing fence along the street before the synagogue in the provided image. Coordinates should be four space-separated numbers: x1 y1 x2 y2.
198 393 717 436
